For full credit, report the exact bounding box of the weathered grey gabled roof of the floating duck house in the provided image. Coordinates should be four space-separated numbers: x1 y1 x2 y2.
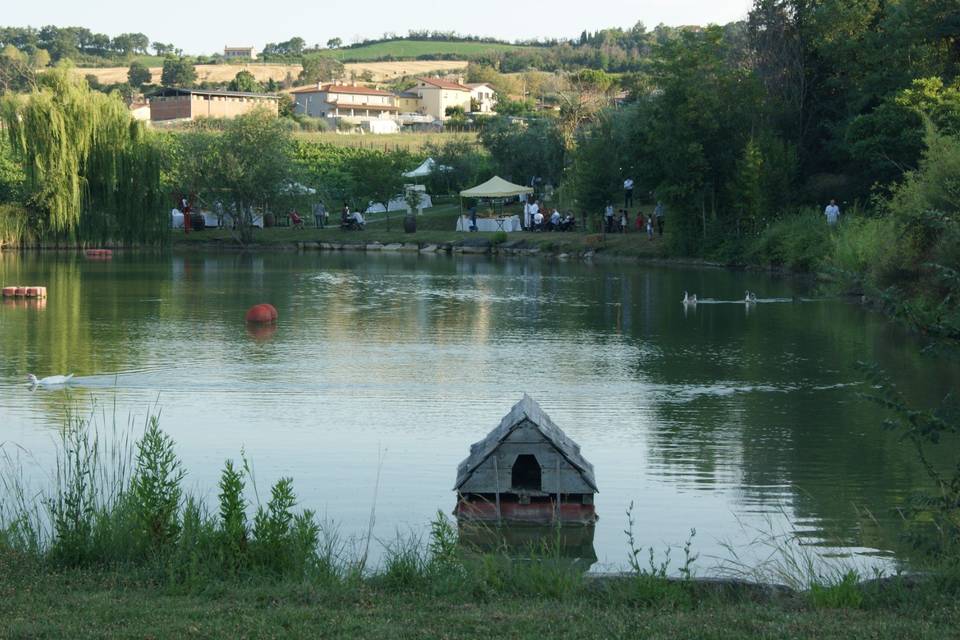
454 394 598 493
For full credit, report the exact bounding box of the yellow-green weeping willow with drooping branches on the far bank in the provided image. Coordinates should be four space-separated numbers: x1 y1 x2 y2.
0 68 168 242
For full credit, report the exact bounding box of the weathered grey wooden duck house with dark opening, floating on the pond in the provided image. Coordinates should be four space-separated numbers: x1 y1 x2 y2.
454 394 597 525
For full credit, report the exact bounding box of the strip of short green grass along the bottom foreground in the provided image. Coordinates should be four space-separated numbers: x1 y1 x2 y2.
0 559 960 639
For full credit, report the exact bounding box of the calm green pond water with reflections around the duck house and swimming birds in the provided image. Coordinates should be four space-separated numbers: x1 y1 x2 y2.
0 254 960 572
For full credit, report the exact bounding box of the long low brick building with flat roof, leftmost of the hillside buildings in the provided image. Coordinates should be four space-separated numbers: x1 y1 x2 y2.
150 87 279 122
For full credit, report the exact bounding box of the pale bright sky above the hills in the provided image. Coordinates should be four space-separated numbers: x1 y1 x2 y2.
0 0 751 54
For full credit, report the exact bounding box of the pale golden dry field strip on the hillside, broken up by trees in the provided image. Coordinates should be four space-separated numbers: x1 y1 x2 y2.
76 60 467 84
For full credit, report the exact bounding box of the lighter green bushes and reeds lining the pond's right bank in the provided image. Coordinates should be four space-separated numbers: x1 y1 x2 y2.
714 126 960 341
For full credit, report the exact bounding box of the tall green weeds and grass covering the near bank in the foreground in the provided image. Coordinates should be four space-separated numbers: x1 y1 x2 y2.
0 410 960 638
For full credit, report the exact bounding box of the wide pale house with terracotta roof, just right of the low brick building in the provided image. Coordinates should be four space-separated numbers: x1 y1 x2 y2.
291 83 399 124
